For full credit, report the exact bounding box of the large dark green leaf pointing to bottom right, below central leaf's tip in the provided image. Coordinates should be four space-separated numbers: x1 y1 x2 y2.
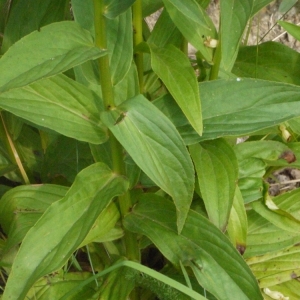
124 194 262 300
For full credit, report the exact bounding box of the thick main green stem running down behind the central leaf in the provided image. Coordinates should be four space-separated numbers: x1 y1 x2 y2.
94 0 139 261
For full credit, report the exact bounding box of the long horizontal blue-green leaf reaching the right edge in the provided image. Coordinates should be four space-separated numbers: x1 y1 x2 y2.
155 78 300 145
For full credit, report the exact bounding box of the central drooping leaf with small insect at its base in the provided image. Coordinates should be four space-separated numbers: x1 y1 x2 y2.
101 95 194 232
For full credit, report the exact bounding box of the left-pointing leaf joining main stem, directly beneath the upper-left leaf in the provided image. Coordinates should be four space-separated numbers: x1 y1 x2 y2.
0 75 107 144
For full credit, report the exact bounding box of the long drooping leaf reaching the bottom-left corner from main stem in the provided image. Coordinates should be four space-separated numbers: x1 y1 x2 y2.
2 163 128 300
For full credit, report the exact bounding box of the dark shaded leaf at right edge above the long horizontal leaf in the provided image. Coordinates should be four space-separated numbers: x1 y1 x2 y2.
232 42 300 85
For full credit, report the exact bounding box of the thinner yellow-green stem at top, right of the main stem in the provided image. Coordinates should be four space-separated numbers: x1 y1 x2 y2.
132 0 144 93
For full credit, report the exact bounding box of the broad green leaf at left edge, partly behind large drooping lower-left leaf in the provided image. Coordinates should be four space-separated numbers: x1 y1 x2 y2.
0 185 68 251
